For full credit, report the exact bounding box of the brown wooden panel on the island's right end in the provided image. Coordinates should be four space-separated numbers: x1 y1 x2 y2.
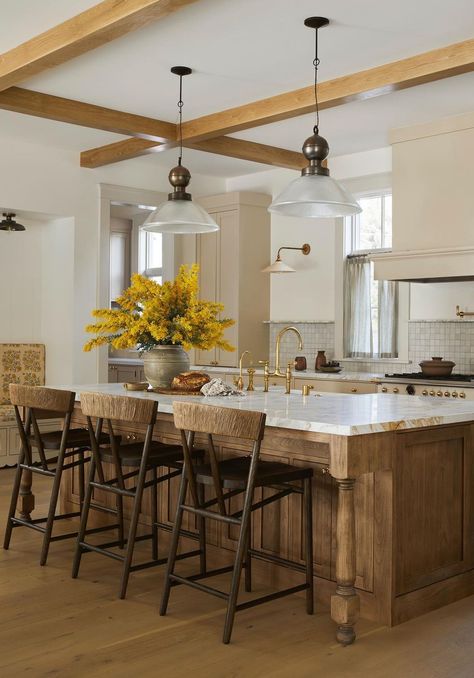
394 426 474 595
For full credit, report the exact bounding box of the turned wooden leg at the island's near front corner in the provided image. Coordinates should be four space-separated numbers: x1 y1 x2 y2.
331 478 360 645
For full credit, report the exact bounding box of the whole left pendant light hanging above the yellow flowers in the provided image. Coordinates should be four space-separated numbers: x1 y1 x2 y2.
142 66 219 233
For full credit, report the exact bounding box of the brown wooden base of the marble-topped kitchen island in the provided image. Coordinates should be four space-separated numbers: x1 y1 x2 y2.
39 404 474 644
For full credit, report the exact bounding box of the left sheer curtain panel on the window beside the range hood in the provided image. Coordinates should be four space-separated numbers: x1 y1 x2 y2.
344 257 373 358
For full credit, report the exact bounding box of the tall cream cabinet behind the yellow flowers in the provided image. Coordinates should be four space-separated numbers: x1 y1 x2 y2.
195 192 271 367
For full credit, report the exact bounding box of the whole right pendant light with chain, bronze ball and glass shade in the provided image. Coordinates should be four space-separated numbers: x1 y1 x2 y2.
268 16 362 218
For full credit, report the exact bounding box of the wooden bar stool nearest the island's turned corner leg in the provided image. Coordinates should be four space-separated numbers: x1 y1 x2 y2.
160 402 313 643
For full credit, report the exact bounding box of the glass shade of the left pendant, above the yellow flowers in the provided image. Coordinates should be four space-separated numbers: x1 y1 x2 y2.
142 200 219 233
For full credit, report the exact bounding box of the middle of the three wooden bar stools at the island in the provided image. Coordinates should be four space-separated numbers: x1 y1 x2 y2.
72 393 205 598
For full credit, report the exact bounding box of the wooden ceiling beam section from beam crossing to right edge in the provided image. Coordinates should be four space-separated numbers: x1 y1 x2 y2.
179 39 474 141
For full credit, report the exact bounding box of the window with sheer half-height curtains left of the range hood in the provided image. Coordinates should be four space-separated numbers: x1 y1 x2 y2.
344 191 398 359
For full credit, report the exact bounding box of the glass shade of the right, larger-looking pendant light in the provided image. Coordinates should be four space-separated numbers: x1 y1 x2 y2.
268 174 362 218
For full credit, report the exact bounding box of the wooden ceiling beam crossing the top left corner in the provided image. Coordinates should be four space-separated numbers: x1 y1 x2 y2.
0 0 200 90
